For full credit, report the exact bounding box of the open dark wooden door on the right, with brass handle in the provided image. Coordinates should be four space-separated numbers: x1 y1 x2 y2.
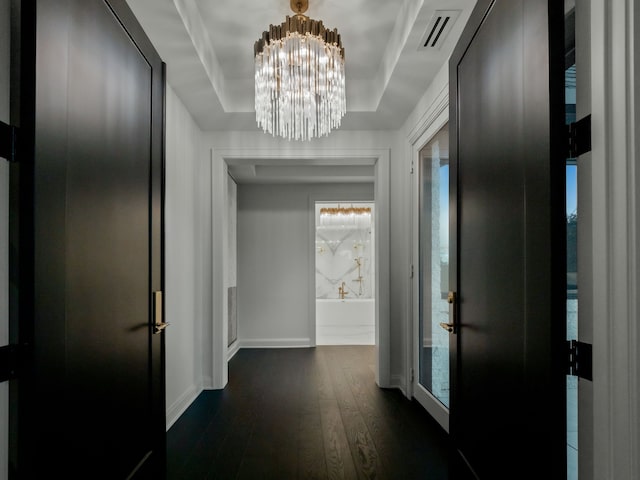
450 0 566 480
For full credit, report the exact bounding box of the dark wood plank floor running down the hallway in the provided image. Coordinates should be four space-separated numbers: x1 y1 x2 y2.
167 346 472 480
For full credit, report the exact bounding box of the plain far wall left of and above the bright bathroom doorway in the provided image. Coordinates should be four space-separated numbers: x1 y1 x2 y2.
238 184 374 347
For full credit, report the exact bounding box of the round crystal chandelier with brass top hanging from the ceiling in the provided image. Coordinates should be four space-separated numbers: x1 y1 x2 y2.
254 0 346 140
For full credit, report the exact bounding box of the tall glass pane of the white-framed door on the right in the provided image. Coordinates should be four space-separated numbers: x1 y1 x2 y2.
418 125 449 408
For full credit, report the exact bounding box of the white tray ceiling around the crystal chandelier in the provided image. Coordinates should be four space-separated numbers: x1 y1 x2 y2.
127 0 476 181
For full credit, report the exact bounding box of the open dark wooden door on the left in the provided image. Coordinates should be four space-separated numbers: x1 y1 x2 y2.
10 0 165 479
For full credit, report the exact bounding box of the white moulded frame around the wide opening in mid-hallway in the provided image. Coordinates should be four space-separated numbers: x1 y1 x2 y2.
207 148 391 389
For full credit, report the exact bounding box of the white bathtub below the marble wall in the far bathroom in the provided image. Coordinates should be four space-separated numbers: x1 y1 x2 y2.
316 298 376 345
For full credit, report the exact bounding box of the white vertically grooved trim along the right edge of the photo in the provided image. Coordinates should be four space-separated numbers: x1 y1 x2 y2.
592 0 640 480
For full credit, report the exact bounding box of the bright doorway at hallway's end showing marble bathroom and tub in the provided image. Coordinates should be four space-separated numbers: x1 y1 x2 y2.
314 202 376 345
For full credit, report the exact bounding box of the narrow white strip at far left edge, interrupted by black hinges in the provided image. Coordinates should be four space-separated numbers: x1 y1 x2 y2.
0 0 10 480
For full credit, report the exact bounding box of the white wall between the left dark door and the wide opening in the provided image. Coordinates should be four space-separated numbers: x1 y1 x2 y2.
165 86 210 428
